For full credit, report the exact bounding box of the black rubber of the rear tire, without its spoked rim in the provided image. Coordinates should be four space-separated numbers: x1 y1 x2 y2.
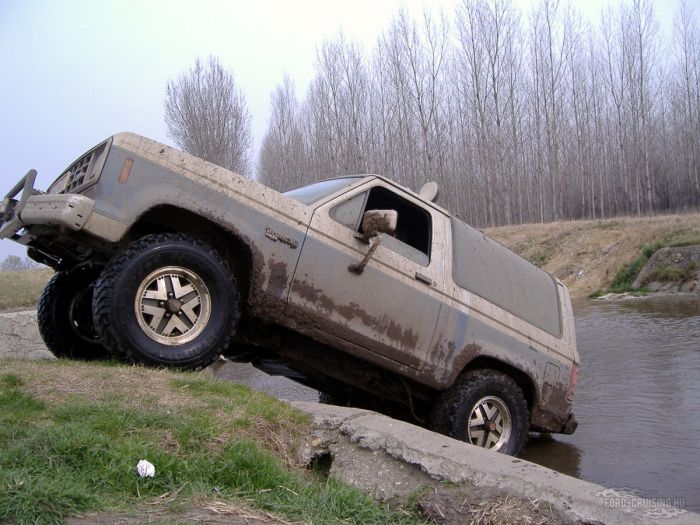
430 369 530 456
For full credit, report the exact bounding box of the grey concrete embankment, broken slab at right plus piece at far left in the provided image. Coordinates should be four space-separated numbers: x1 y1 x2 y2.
0 312 700 525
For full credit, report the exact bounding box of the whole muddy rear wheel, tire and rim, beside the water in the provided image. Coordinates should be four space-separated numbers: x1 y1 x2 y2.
430 369 530 456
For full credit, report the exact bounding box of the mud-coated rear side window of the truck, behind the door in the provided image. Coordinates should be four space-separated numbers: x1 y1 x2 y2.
451 217 561 337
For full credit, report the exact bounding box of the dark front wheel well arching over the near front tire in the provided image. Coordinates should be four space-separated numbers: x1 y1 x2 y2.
125 206 253 304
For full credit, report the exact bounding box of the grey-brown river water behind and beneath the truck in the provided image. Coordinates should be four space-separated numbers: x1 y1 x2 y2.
217 296 700 512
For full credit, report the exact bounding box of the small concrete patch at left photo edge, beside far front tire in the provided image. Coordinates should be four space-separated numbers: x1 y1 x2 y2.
0 310 55 360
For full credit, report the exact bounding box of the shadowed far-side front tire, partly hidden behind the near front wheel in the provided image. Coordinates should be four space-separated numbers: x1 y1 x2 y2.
37 268 109 360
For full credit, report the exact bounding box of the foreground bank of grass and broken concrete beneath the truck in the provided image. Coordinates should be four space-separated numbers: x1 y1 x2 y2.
0 360 696 525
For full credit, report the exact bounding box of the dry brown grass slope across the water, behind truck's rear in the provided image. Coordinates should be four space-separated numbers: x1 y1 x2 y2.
484 213 700 297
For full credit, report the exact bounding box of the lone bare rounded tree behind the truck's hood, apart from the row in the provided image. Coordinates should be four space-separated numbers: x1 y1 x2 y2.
165 56 252 175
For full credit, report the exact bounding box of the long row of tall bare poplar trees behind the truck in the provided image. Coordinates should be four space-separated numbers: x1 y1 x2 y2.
166 0 700 226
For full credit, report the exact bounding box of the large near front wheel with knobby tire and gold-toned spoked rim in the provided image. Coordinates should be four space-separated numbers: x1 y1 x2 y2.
93 233 240 370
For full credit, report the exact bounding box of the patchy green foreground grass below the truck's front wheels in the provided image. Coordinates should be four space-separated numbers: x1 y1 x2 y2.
0 361 418 523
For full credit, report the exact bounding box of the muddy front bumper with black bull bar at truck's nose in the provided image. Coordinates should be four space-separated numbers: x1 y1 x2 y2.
0 170 95 244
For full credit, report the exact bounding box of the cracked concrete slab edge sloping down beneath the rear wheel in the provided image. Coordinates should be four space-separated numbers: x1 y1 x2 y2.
292 401 700 525
